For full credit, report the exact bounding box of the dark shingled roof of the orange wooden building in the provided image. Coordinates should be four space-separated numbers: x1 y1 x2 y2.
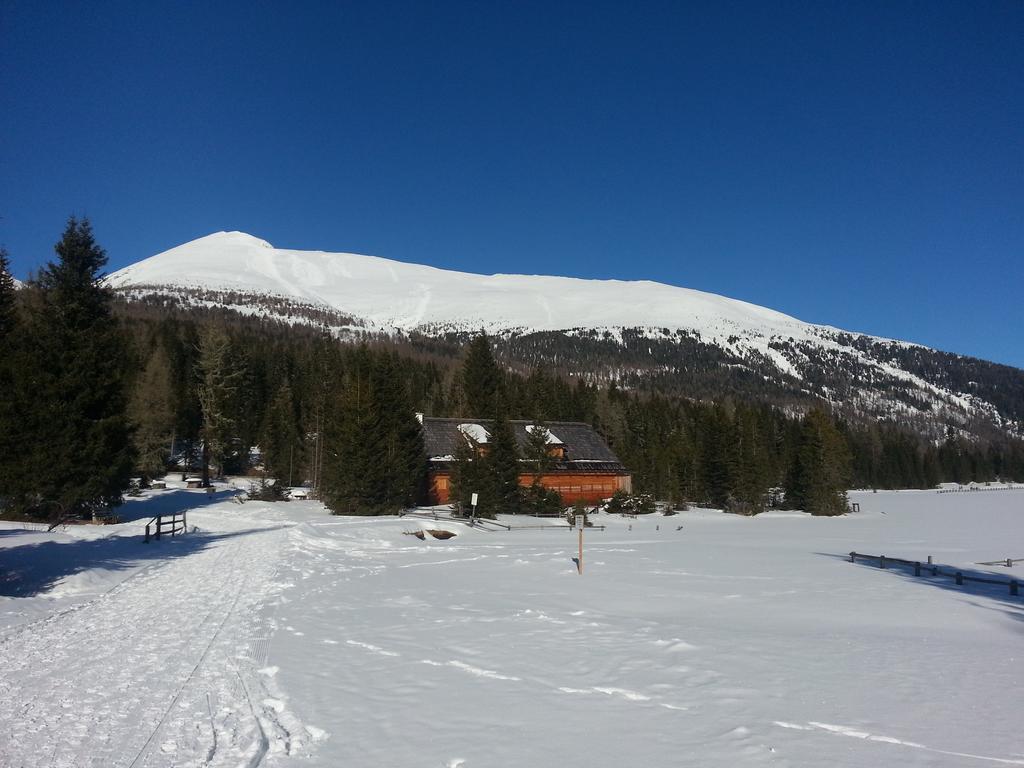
423 417 622 471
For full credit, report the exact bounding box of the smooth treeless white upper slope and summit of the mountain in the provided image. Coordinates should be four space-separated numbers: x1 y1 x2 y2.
110 232 839 338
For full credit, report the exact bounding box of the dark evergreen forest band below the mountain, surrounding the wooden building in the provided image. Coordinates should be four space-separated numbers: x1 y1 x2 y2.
0 219 1024 516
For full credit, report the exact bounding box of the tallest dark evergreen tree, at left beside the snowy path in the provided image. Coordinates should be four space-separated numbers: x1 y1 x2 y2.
18 218 133 516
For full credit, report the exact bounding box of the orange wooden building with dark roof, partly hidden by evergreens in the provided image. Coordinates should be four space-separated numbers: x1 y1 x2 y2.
422 417 633 504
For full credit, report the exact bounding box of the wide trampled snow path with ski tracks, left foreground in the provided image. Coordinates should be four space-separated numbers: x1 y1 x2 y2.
0 512 301 768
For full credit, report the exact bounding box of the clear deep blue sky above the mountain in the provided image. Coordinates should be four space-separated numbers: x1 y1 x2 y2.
0 0 1024 368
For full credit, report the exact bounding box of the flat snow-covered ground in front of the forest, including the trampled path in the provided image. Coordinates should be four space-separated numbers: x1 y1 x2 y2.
0 489 1024 768
